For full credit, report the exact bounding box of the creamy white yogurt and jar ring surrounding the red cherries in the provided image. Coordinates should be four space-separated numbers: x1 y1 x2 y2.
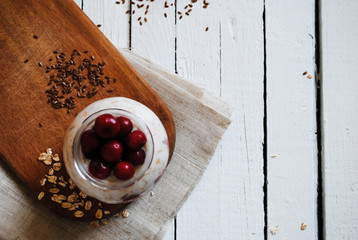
63 97 169 204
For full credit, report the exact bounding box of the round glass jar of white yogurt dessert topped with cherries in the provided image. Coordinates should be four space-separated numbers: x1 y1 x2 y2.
63 97 169 204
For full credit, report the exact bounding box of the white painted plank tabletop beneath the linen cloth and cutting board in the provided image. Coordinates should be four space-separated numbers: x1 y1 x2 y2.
76 0 358 240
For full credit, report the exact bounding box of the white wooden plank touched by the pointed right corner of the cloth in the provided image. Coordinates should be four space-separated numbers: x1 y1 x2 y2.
220 0 265 240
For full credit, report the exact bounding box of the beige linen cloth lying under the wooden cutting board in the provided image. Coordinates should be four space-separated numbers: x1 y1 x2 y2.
0 50 233 240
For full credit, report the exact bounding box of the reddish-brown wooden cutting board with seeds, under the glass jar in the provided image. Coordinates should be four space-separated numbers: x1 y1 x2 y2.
0 0 175 220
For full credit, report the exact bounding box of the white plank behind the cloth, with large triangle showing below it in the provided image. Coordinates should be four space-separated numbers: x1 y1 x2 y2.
176 1 222 240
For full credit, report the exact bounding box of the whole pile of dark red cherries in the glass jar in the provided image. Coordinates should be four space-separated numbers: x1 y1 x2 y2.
80 114 147 180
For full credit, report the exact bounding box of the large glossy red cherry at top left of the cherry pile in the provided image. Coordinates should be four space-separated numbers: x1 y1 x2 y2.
94 114 121 139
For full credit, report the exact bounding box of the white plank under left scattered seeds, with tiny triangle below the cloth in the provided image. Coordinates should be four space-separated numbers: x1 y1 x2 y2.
131 1 175 240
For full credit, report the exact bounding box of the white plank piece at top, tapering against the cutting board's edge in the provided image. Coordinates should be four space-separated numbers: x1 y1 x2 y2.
83 0 130 48
